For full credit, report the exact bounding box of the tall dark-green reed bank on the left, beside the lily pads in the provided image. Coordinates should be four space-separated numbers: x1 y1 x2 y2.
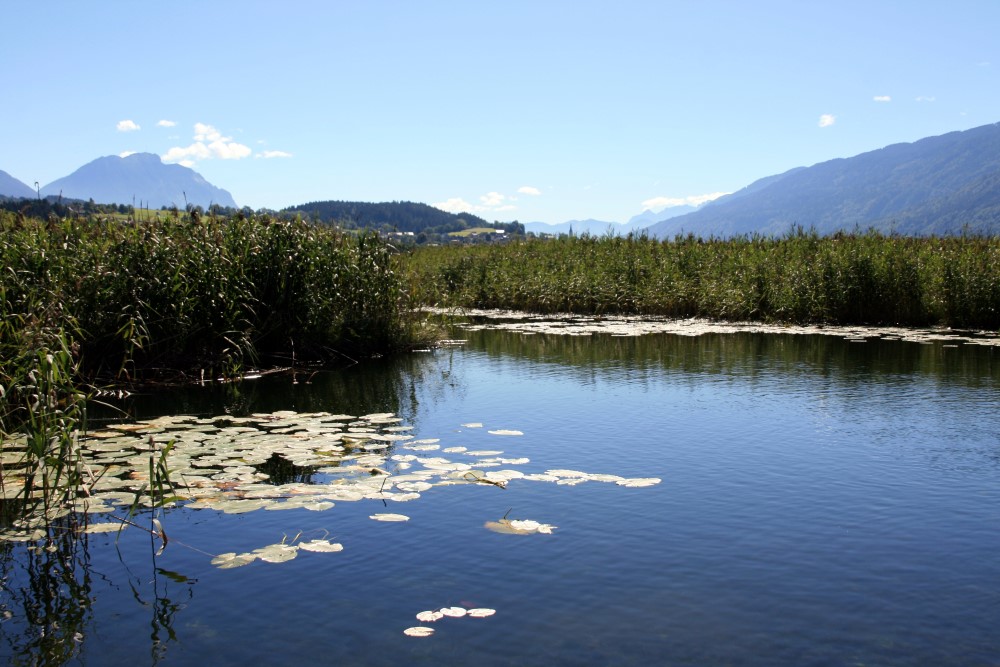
0 212 417 520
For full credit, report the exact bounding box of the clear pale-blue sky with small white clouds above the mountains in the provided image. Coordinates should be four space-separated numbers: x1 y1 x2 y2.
0 0 1000 223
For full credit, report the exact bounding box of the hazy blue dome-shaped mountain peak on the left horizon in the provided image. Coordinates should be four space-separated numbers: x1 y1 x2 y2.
42 153 236 208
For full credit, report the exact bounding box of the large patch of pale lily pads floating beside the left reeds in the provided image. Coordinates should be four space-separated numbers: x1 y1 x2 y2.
0 411 660 552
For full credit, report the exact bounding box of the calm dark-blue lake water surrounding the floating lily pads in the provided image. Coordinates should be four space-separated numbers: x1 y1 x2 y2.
0 320 1000 666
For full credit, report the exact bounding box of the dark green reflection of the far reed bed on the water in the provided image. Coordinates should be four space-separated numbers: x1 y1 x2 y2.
459 330 1000 389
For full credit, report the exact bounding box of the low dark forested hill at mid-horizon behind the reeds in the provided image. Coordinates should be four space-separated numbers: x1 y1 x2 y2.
285 201 495 234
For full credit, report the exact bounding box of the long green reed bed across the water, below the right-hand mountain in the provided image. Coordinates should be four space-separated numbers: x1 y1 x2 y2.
406 230 1000 330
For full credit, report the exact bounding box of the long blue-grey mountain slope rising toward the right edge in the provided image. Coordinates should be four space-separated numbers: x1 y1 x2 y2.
648 123 1000 238
